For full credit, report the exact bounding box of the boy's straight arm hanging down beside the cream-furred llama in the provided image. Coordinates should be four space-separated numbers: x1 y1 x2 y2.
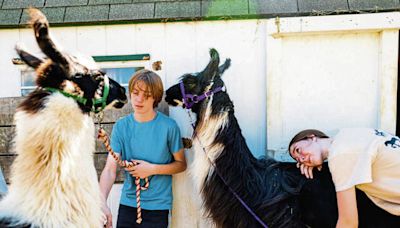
99 155 117 228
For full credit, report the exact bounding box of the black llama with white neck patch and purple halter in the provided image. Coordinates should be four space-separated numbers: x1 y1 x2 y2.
165 49 400 228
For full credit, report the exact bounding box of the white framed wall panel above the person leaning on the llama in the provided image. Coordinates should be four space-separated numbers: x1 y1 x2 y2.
266 12 400 160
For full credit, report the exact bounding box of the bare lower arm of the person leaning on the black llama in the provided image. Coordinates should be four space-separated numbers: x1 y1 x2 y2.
336 186 358 228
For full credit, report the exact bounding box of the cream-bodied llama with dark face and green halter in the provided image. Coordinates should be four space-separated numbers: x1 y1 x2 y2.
0 9 127 228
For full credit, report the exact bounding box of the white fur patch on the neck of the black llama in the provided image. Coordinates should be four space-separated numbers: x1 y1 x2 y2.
189 96 228 192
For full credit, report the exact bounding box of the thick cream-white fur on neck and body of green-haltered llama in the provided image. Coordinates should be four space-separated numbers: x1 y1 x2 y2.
0 93 102 228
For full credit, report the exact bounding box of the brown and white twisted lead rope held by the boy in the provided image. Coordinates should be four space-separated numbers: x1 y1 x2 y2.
97 114 150 224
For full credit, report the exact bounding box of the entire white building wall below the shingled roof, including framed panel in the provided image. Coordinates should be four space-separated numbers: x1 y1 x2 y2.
0 12 400 227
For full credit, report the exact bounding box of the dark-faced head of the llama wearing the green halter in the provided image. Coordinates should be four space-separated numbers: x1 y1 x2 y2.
16 9 127 112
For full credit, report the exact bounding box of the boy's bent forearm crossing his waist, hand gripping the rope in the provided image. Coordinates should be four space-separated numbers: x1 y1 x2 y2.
126 148 186 178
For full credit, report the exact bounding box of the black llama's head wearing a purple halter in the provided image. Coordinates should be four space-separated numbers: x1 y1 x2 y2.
165 48 232 113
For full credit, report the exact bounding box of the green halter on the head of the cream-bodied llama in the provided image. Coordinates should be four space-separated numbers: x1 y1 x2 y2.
44 75 110 113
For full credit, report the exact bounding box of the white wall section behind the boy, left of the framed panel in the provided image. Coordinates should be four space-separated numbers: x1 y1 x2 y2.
0 20 266 227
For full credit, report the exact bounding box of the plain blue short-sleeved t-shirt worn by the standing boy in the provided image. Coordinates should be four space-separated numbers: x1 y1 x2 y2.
111 112 183 210
